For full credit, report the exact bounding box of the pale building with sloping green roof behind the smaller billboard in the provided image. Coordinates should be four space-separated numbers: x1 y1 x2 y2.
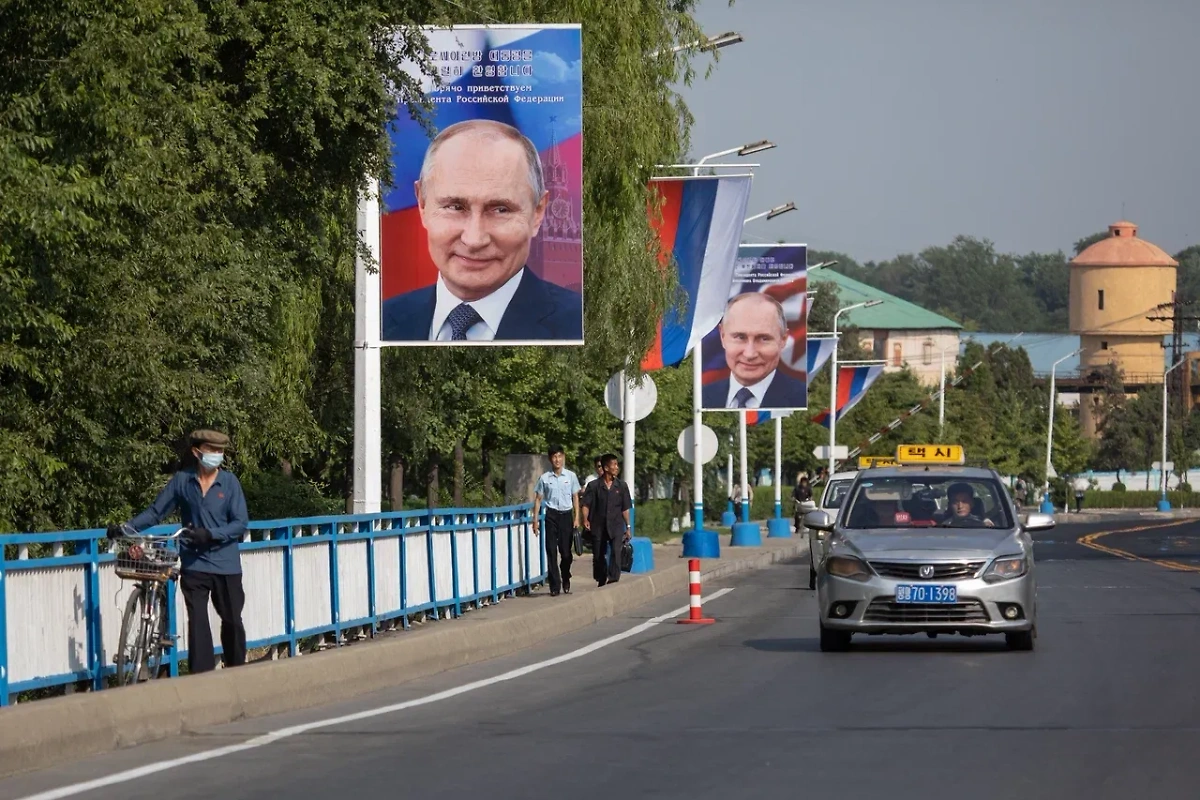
809 269 962 384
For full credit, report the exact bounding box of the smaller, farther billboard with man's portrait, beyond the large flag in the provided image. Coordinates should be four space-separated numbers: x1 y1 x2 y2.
701 245 809 411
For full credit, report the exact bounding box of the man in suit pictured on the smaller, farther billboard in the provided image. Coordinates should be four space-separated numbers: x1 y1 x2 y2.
701 291 808 410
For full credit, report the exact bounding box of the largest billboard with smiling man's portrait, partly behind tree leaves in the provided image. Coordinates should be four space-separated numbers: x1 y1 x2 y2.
380 25 583 345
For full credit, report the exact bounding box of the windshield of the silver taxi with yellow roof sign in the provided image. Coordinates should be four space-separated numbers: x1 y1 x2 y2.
842 473 1012 529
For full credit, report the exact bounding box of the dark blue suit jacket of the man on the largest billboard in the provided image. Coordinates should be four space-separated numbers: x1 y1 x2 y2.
383 267 583 342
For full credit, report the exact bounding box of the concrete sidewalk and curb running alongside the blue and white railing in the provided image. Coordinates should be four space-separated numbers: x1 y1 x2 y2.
0 525 808 776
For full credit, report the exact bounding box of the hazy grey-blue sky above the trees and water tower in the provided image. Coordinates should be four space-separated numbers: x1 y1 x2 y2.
684 0 1200 261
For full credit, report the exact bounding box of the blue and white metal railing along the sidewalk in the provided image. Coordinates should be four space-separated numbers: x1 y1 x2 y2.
0 503 546 705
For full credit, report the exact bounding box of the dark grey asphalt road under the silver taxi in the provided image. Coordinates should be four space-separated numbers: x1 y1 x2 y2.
7 522 1200 800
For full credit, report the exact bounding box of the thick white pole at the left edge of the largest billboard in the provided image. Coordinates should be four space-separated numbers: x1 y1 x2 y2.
352 178 383 513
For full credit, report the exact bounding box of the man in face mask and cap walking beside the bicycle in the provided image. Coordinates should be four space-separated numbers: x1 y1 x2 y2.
108 431 250 673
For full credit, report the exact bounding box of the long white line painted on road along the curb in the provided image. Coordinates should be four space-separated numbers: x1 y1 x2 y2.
18 587 733 800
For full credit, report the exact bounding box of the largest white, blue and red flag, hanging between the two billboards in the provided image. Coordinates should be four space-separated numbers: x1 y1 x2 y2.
642 175 750 371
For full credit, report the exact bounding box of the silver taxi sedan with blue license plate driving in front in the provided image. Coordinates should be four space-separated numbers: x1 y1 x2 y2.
804 467 1054 651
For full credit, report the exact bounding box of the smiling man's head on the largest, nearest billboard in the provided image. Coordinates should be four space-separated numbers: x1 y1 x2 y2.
415 124 547 302
